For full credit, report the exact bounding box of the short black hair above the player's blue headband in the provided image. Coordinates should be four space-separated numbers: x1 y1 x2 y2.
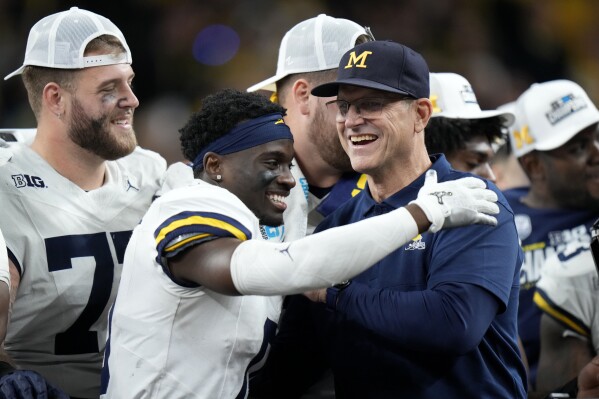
179 89 285 166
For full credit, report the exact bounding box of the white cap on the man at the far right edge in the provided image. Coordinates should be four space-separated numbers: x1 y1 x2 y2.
510 80 599 157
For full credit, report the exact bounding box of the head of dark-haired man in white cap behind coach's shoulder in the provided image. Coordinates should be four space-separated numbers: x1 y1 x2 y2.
424 73 514 182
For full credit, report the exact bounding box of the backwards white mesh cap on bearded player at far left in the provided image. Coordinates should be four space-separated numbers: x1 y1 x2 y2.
4 7 132 80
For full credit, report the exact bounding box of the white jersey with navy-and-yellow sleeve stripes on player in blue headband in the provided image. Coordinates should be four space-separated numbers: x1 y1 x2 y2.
102 180 282 399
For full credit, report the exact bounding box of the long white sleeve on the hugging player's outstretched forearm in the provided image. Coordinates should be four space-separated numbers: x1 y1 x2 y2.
231 208 418 295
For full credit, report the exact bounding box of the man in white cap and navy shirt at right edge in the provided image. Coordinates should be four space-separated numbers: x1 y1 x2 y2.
505 80 599 391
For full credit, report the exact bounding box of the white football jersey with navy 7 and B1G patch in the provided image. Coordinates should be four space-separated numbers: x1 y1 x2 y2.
0 144 166 398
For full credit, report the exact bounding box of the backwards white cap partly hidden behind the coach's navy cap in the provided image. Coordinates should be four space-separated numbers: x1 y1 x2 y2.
247 14 370 91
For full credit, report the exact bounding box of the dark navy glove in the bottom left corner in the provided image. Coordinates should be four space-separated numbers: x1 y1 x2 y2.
0 370 69 399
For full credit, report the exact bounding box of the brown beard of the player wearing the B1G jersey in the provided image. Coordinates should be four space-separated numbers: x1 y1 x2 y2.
68 98 137 161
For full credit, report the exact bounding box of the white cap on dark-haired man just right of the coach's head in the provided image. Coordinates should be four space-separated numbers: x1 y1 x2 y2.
430 72 515 126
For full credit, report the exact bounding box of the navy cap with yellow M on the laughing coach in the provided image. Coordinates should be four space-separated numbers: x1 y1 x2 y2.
312 41 430 98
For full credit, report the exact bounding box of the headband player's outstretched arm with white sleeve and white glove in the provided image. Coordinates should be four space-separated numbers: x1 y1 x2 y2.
168 176 499 295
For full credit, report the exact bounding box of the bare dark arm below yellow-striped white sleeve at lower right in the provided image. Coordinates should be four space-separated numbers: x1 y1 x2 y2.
536 313 595 393
